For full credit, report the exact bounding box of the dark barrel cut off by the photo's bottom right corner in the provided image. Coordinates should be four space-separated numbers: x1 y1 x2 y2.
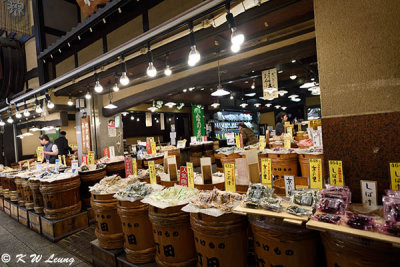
321 231 400 267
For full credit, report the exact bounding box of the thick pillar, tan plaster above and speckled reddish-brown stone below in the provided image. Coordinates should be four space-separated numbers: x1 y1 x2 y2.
314 0 400 202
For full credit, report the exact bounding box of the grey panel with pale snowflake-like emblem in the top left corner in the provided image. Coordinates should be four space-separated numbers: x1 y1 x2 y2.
0 0 32 36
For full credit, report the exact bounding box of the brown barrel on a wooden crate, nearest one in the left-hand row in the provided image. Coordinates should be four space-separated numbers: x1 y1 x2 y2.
39 175 82 220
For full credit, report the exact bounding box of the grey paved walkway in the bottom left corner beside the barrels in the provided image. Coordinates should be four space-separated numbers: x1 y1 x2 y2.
0 212 91 267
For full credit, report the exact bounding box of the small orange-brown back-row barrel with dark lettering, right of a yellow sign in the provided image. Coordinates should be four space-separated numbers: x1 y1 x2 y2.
268 153 298 179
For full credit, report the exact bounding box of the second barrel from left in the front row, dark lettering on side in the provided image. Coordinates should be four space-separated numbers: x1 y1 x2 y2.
118 200 156 264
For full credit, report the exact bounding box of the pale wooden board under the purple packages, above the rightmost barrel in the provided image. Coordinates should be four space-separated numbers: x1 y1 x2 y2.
306 220 400 247
